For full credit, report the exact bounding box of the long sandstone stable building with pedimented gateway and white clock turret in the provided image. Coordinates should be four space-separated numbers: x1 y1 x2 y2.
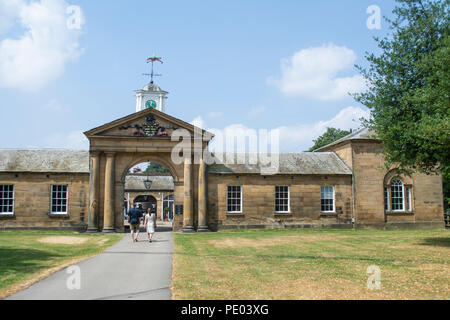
0 79 444 232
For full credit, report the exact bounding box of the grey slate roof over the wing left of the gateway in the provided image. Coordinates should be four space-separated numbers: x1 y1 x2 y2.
0 149 89 173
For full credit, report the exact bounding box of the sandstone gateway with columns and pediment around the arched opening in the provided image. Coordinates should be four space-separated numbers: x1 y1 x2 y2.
84 109 212 232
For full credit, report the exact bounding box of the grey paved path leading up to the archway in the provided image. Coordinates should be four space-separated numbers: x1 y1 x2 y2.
8 232 173 300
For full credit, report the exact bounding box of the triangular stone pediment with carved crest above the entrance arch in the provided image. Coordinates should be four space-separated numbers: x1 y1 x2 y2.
84 109 213 140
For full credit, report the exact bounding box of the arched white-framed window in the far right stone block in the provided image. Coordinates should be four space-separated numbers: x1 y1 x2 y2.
384 179 412 212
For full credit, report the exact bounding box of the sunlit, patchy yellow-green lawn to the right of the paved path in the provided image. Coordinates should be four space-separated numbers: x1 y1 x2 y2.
172 229 450 299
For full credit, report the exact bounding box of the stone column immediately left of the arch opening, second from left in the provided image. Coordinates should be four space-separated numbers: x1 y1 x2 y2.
103 152 115 232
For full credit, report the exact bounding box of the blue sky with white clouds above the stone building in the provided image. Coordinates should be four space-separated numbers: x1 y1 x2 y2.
0 0 395 152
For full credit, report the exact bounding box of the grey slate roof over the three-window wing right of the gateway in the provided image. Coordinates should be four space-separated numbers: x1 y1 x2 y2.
208 152 352 175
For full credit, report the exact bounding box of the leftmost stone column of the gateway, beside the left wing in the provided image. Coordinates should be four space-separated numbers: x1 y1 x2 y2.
87 152 99 232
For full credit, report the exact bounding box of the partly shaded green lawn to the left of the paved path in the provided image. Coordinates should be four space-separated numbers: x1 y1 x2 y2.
0 231 123 298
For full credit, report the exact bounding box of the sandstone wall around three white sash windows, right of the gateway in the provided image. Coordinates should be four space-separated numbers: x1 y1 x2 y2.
207 174 352 229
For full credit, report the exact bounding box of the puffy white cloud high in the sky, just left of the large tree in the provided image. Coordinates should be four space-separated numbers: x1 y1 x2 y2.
268 43 365 101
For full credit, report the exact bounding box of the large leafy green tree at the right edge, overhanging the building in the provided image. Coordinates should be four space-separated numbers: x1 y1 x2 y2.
355 0 450 208
